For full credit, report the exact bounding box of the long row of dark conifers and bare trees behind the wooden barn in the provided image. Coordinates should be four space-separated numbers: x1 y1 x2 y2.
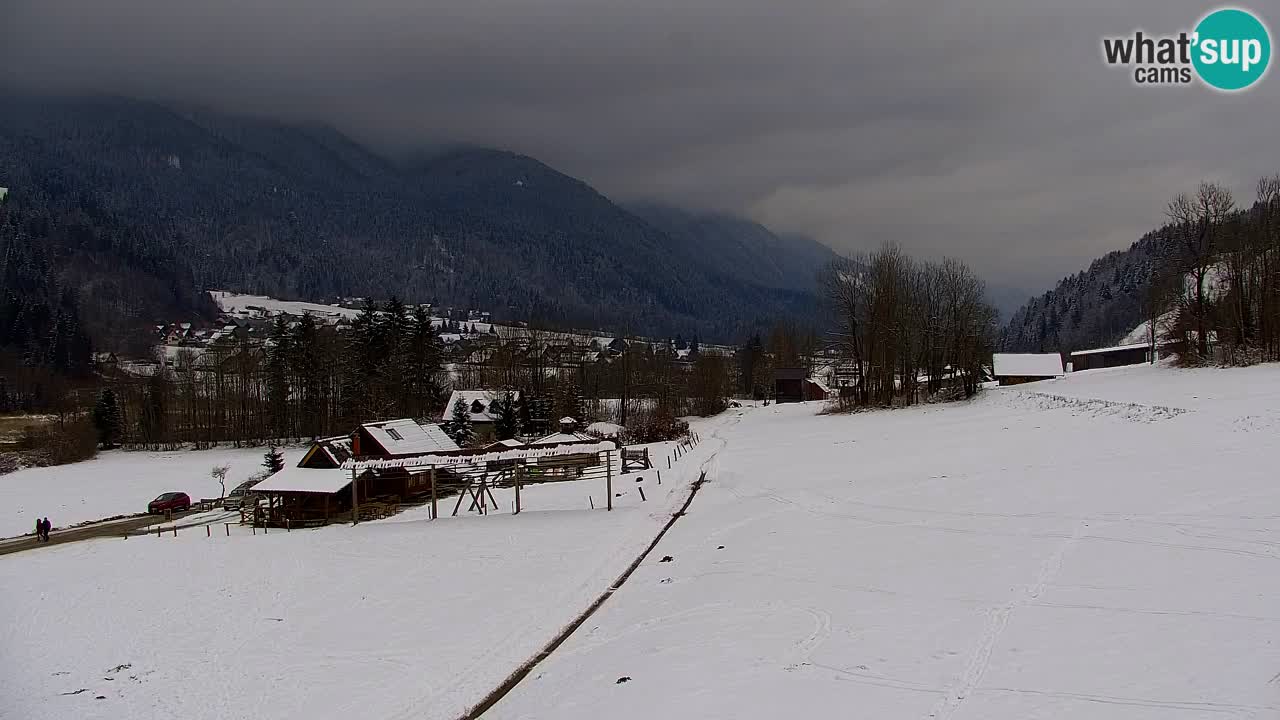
92 299 735 448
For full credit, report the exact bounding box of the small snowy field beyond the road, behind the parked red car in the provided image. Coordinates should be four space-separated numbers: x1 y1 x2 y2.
0 447 303 538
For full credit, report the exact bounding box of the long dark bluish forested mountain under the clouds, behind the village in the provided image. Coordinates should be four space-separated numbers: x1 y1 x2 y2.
0 95 829 340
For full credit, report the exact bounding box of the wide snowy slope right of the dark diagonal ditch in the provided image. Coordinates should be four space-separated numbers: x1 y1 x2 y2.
488 365 1280 720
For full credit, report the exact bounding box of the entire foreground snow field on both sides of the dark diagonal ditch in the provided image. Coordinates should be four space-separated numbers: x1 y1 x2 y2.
0 365 1280 720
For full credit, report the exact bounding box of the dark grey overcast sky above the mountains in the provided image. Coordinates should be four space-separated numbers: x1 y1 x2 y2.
0 0 1280 291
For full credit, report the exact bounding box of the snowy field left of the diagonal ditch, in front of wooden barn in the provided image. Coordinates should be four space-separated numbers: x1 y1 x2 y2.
0 427 731 720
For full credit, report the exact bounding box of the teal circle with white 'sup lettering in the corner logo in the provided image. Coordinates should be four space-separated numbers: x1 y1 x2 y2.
1192 8 1271 91
